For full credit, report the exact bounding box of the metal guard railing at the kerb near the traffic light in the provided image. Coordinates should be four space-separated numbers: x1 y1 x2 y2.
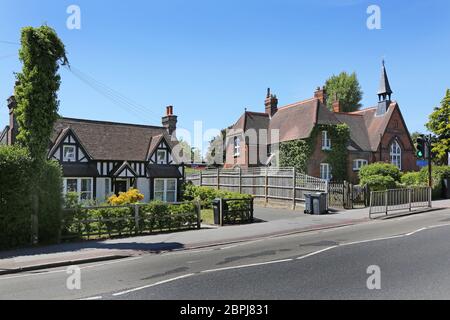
369 187 432 218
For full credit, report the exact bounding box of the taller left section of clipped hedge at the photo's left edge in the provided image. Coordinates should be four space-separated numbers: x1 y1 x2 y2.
0 146 32 249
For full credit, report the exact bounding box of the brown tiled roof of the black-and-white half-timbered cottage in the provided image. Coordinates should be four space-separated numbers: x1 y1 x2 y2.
51 118 174 161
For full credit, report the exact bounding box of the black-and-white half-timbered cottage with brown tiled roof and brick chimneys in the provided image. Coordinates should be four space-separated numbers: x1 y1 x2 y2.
0 100 184 202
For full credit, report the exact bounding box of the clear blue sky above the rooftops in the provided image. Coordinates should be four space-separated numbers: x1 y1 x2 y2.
0 0 450 151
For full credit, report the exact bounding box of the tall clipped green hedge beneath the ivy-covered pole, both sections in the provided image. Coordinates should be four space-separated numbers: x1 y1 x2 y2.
0 146 62 249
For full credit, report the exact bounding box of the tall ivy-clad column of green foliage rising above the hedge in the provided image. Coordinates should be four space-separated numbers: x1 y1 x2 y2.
14 26 67 161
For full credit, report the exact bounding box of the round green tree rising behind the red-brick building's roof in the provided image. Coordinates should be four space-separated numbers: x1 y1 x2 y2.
325 72 363 112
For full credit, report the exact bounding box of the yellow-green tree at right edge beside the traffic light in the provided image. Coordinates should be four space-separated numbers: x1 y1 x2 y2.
425 89 450 165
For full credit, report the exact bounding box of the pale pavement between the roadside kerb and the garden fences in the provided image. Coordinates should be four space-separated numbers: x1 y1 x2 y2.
0 200 450 275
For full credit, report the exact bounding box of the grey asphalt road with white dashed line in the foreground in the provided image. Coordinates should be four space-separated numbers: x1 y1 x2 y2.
0 210 450 300
